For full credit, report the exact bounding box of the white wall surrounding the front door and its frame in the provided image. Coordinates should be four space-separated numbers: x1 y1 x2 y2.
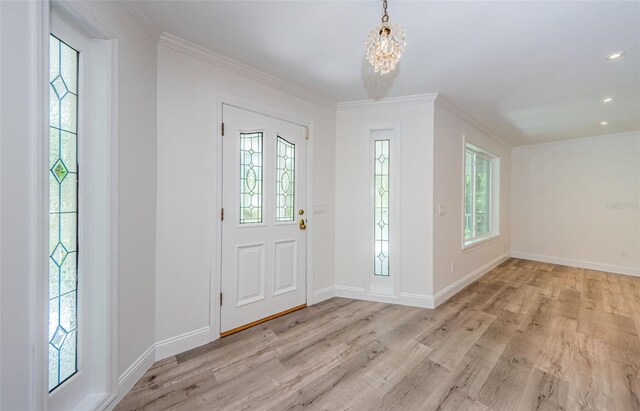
155 38 335 350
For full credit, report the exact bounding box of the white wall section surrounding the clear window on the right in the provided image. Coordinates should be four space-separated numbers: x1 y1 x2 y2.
433 98 511 303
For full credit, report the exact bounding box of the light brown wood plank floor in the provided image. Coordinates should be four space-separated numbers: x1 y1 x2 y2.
116 259 640 410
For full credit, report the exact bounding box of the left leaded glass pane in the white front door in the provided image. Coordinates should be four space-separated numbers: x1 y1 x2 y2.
240 132 262 224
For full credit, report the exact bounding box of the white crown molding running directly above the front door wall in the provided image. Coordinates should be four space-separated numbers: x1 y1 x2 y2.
158 32 336 109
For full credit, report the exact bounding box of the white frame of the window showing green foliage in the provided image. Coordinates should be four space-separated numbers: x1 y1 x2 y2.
461 141 500 251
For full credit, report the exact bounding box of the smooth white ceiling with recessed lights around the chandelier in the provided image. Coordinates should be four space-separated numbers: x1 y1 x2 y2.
137 0 640 146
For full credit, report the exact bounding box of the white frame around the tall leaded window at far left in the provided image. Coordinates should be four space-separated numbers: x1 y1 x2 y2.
43 2 119 409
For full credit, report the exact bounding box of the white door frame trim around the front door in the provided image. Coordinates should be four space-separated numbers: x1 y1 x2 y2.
209 94 315 341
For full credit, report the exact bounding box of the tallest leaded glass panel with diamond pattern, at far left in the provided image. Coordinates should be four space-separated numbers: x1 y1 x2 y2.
48 35 78 391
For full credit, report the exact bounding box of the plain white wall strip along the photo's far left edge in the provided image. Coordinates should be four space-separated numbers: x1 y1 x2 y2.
0 2 38 410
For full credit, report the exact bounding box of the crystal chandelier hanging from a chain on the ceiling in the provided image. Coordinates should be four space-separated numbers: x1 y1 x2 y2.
366 0 407 75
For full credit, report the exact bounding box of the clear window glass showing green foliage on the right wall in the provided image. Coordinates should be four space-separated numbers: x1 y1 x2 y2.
464 144 498 246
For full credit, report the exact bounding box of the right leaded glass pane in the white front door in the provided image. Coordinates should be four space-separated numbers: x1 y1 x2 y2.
276 136 296 222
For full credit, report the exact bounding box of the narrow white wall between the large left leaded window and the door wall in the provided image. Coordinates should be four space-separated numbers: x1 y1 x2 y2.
70 1 157 384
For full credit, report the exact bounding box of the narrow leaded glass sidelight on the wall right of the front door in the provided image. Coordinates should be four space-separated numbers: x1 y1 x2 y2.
373 140 390 277
